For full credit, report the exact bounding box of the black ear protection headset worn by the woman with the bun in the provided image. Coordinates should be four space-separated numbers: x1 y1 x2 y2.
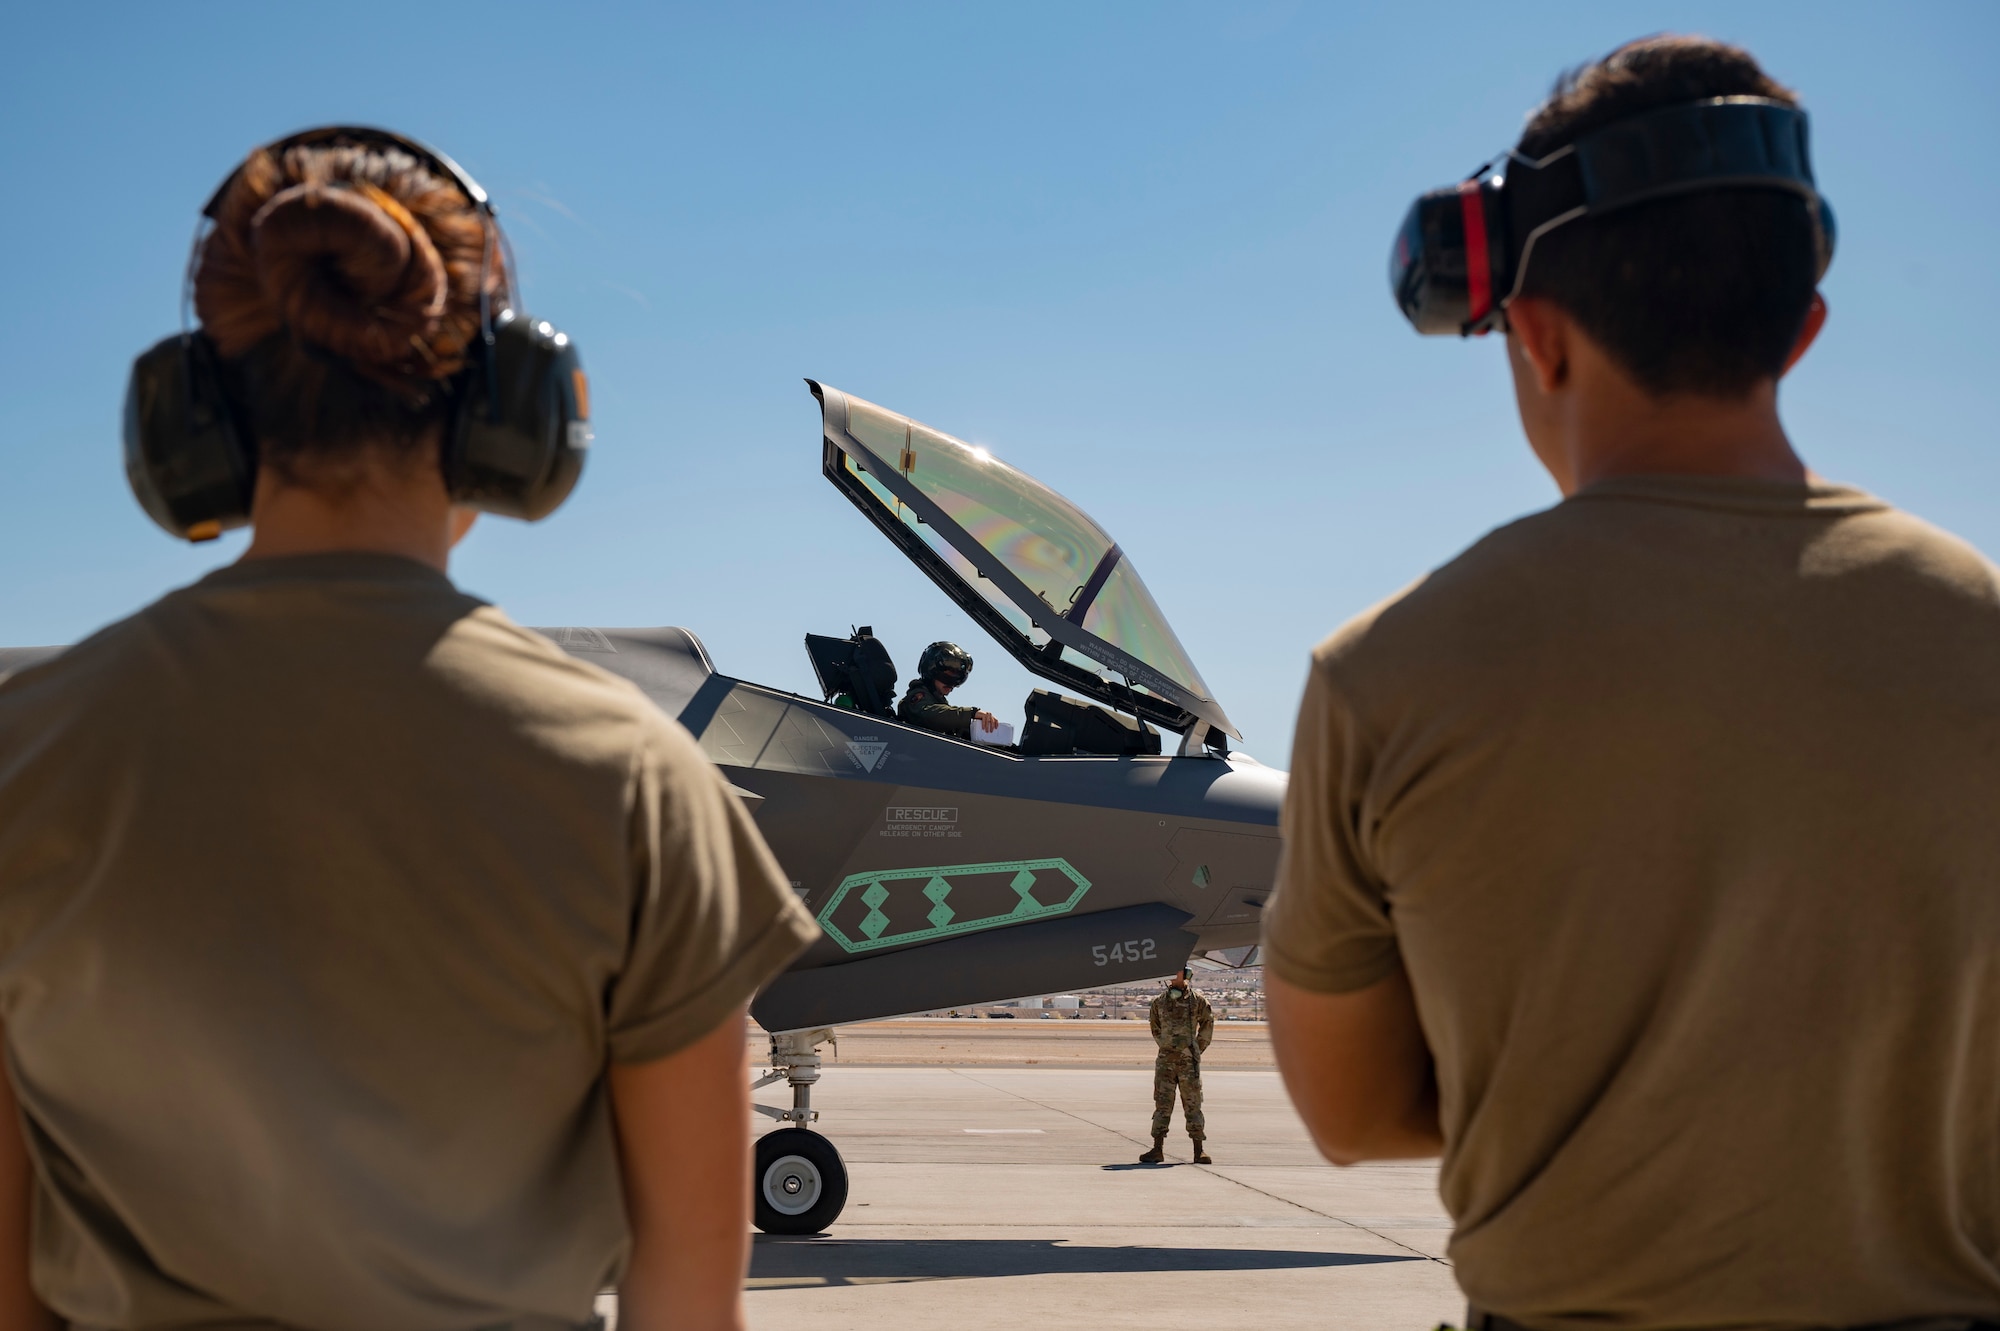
124 126 592 542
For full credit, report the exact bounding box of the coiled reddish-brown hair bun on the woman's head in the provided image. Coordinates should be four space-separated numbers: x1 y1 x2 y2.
250 184 446 378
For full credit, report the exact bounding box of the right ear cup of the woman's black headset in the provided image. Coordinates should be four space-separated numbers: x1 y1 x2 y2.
456 310 590 522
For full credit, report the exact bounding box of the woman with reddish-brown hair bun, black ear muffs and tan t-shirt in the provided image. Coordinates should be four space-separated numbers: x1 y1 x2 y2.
0 126 816 1331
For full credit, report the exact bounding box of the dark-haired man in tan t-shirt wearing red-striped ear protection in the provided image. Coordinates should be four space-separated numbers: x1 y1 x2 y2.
1264 36 2000 1331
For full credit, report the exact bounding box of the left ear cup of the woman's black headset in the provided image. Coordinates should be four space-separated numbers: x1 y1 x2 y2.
124 332 256 542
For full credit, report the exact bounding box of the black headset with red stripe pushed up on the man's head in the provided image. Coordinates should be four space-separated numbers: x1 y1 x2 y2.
1388 98 1834 338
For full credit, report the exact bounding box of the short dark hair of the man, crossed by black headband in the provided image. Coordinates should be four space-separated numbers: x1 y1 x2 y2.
1516 36 1818 398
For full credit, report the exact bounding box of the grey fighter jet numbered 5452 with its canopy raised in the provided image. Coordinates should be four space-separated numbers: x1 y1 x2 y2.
0 384 1284 1233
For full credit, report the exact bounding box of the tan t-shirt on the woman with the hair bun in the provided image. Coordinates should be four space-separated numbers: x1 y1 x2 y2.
0 556 816 1331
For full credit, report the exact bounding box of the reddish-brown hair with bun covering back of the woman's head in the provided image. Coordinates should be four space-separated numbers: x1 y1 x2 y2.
194 142 506 484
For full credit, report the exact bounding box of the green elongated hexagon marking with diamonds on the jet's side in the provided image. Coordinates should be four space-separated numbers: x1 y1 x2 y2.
820 859 1090 953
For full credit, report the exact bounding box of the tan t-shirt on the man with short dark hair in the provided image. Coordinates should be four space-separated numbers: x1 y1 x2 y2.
1264 478 2000 1327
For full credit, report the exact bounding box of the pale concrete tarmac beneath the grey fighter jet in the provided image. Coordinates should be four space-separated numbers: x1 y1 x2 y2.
732 1021 1464 1331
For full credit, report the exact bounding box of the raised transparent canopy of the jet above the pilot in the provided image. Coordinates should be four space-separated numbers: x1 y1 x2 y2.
808 380 1236 735
